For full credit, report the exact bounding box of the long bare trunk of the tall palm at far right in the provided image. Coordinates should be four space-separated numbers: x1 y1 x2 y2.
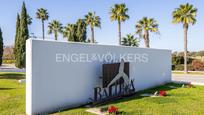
184 27 188 74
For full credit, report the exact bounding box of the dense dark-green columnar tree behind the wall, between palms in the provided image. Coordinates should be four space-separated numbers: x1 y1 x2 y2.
76 19 86 42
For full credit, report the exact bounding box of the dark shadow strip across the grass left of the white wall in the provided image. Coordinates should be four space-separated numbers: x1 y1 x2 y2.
0 73 25 80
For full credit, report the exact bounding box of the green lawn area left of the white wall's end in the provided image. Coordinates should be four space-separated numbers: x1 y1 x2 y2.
0 72 25 115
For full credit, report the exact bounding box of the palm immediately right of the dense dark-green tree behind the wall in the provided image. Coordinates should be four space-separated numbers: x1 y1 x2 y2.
85 12 101 43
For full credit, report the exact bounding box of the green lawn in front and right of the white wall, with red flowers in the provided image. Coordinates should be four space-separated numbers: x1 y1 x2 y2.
57 83 204 115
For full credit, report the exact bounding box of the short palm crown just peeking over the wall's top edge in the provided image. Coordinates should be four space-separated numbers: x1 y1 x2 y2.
122 34 139 47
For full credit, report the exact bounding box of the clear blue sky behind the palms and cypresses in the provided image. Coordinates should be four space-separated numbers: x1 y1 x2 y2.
0 0 204 51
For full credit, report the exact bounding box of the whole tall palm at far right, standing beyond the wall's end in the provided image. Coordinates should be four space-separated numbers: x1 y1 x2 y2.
172 3 197 73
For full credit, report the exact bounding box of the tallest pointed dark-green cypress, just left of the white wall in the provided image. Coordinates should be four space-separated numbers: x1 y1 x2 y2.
17 2 29 68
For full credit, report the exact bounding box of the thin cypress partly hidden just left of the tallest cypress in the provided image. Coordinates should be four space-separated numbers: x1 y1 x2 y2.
14 14 20 67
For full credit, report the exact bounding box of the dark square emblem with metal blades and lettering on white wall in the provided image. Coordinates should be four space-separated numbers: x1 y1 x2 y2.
94 60 135 102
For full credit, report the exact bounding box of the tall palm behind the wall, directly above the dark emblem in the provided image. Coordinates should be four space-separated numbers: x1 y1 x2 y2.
110 4 129 45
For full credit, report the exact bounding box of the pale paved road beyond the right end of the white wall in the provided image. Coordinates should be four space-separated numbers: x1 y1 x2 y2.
172 75 204 84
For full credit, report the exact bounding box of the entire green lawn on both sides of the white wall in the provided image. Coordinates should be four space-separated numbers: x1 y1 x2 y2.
0 73 204 115
